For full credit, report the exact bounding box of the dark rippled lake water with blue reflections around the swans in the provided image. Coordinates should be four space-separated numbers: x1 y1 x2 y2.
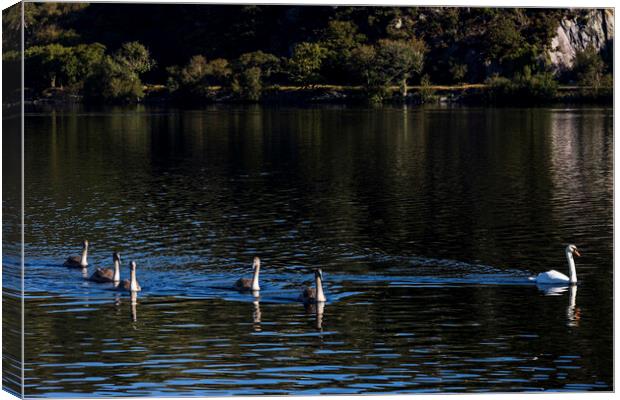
4 106 614 396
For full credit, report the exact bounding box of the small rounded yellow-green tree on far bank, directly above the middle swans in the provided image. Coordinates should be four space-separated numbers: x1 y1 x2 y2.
287 42 327 86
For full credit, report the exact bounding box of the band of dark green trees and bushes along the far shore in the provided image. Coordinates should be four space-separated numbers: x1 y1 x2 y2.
18 2 613 101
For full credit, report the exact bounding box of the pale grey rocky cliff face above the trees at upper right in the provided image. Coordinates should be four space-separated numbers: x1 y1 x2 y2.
549 9 614 71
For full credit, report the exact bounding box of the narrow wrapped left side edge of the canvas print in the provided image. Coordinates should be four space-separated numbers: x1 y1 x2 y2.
2 3 24 397
